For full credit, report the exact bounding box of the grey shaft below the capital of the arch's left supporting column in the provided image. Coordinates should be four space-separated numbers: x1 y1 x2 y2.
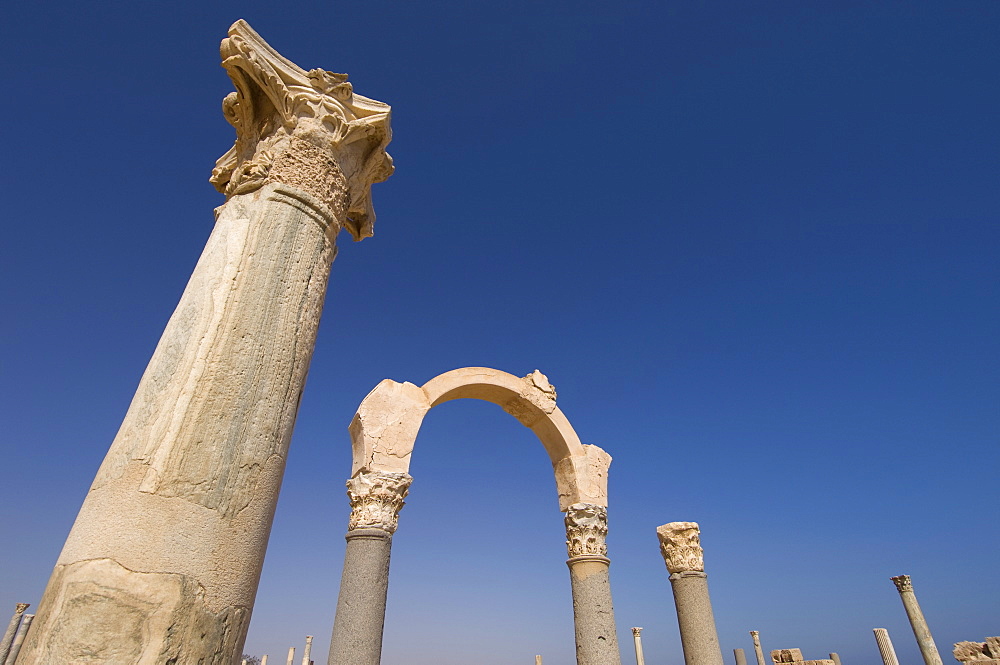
329 529 392 665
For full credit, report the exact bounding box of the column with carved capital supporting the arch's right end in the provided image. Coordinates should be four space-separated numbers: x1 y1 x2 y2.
565 503 622 665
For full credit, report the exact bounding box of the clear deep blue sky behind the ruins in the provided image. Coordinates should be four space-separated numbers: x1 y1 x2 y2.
0 0 1000 665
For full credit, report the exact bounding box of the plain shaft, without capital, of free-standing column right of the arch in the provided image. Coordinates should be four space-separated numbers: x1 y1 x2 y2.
670 571 723 665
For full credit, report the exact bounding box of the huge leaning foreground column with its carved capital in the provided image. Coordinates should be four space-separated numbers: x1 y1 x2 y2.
20 21 392 665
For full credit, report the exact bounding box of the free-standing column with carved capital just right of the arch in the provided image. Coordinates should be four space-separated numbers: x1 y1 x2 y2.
656 522 723 665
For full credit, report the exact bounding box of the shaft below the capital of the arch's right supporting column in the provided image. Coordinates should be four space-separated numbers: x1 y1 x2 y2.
566 555 621 665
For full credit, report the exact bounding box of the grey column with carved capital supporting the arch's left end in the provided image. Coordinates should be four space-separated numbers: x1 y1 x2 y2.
329 471 413 665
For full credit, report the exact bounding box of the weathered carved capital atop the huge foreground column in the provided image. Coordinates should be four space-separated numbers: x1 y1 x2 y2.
210 20 392 240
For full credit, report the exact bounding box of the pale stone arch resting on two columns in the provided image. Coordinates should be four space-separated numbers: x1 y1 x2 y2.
349 367 611 512
